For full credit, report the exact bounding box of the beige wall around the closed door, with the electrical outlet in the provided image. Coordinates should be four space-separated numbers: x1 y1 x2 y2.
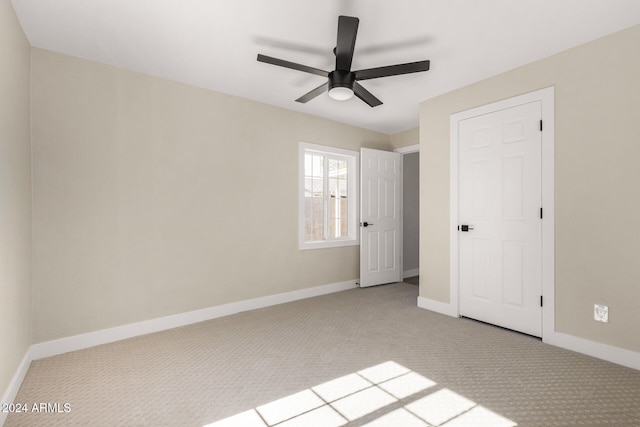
420 26 640 352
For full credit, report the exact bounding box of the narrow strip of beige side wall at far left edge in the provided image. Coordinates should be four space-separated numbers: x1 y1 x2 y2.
0 0 31 398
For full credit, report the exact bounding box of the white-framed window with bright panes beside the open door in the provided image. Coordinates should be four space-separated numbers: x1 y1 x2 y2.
298 142 359 249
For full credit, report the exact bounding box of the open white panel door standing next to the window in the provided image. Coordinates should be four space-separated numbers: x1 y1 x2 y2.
360 148 402 287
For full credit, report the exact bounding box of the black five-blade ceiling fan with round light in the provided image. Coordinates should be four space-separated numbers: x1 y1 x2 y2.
258 16 429 107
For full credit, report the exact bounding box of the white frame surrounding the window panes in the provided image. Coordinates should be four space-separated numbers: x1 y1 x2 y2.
298 142 360 250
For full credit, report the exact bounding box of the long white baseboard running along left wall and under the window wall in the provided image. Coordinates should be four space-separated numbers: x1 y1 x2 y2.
0 279 358 420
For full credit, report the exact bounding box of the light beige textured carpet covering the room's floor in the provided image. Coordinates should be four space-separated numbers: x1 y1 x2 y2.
5 284 640 427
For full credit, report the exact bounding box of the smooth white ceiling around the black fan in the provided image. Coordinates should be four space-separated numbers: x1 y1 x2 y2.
12 0 640 134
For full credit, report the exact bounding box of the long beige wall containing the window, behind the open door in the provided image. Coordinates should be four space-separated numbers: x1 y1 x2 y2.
32 49 389 342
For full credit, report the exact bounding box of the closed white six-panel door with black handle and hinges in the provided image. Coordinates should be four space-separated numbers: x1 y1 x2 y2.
458 101 542 336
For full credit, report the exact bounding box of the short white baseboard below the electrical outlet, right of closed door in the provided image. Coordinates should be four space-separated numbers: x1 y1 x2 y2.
543 332 640 370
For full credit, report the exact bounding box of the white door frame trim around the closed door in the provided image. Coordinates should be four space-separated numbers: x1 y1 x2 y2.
449 86 555 341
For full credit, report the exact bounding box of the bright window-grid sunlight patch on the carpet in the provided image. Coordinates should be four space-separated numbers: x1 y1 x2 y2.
204 361 518 427
